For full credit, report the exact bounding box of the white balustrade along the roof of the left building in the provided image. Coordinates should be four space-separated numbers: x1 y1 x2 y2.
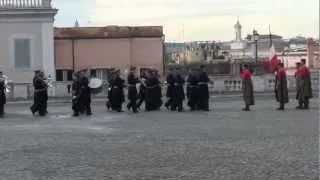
0 0 51 9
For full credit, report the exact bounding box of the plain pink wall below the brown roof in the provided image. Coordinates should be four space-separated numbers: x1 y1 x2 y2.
55 38 163 72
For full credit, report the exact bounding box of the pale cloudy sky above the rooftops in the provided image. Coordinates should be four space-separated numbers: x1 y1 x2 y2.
52 0 319 42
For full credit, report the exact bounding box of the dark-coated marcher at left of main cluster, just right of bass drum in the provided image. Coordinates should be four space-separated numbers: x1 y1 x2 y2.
110 71 125 112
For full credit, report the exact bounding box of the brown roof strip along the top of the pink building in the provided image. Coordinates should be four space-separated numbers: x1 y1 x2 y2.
54 26 163 39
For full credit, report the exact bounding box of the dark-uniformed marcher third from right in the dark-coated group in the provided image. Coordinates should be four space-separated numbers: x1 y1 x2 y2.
171 73 185 112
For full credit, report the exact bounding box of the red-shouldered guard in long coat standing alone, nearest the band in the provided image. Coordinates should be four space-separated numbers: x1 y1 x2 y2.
241 65 254 111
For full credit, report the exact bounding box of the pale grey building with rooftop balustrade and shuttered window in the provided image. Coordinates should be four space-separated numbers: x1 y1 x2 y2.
0 0 57 83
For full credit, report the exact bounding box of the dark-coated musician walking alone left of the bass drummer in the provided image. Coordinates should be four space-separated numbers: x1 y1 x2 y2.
30 71 48 116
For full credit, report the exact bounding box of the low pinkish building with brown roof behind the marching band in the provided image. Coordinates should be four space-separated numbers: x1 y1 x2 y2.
54 26 164 81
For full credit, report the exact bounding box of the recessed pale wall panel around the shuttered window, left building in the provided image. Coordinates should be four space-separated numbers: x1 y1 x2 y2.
0 21 42 82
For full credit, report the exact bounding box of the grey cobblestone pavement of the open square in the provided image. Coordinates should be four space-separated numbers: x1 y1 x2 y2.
0 98 319 180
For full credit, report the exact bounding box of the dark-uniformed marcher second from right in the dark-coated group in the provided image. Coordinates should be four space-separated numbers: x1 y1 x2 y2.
187 69 199 111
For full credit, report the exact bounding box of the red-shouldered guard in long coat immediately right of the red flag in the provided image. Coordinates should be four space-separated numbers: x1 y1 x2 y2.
275 63 289 110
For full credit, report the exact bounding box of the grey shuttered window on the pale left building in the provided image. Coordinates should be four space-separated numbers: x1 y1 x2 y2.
14 39 31 68
